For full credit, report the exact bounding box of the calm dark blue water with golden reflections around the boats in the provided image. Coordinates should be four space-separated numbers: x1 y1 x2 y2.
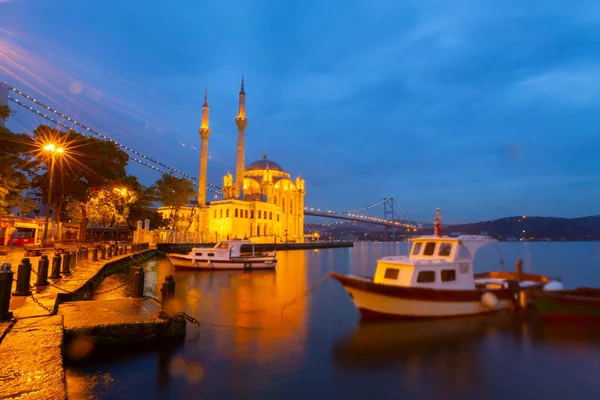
67 242 600 399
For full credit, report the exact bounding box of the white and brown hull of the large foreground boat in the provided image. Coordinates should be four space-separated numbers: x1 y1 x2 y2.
329 273 514 319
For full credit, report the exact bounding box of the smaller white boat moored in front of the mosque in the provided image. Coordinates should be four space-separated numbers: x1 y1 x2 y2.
167 239 277 271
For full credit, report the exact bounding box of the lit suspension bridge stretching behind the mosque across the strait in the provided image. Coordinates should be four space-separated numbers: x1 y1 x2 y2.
0 82 418 231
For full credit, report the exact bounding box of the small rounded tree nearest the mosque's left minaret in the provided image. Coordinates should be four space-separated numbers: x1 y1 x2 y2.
151 174 196 229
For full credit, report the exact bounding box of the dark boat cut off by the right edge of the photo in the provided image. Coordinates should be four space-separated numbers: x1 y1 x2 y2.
533 288 600 320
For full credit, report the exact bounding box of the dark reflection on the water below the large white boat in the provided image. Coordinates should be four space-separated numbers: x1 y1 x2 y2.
333 313 512 368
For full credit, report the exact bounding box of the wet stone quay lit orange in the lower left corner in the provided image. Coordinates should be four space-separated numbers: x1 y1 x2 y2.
0 248 185 399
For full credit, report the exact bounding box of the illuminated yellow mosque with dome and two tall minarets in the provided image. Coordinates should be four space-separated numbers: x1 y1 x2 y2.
158 76 306 243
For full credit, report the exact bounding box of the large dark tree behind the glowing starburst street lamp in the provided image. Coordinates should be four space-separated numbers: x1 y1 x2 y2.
33 125 129 240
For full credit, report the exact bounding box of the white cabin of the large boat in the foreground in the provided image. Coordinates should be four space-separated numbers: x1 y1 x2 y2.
373 235 496 290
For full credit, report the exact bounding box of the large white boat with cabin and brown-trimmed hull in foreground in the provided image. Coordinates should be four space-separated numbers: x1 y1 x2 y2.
329 209 562 318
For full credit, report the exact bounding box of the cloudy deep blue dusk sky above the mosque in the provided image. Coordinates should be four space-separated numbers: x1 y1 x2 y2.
0 0 600 223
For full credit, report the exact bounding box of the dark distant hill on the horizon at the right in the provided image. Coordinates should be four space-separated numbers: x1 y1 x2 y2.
434 215 600 240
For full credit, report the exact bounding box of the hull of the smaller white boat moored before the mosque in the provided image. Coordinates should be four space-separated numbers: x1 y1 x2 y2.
167 254 277 271
